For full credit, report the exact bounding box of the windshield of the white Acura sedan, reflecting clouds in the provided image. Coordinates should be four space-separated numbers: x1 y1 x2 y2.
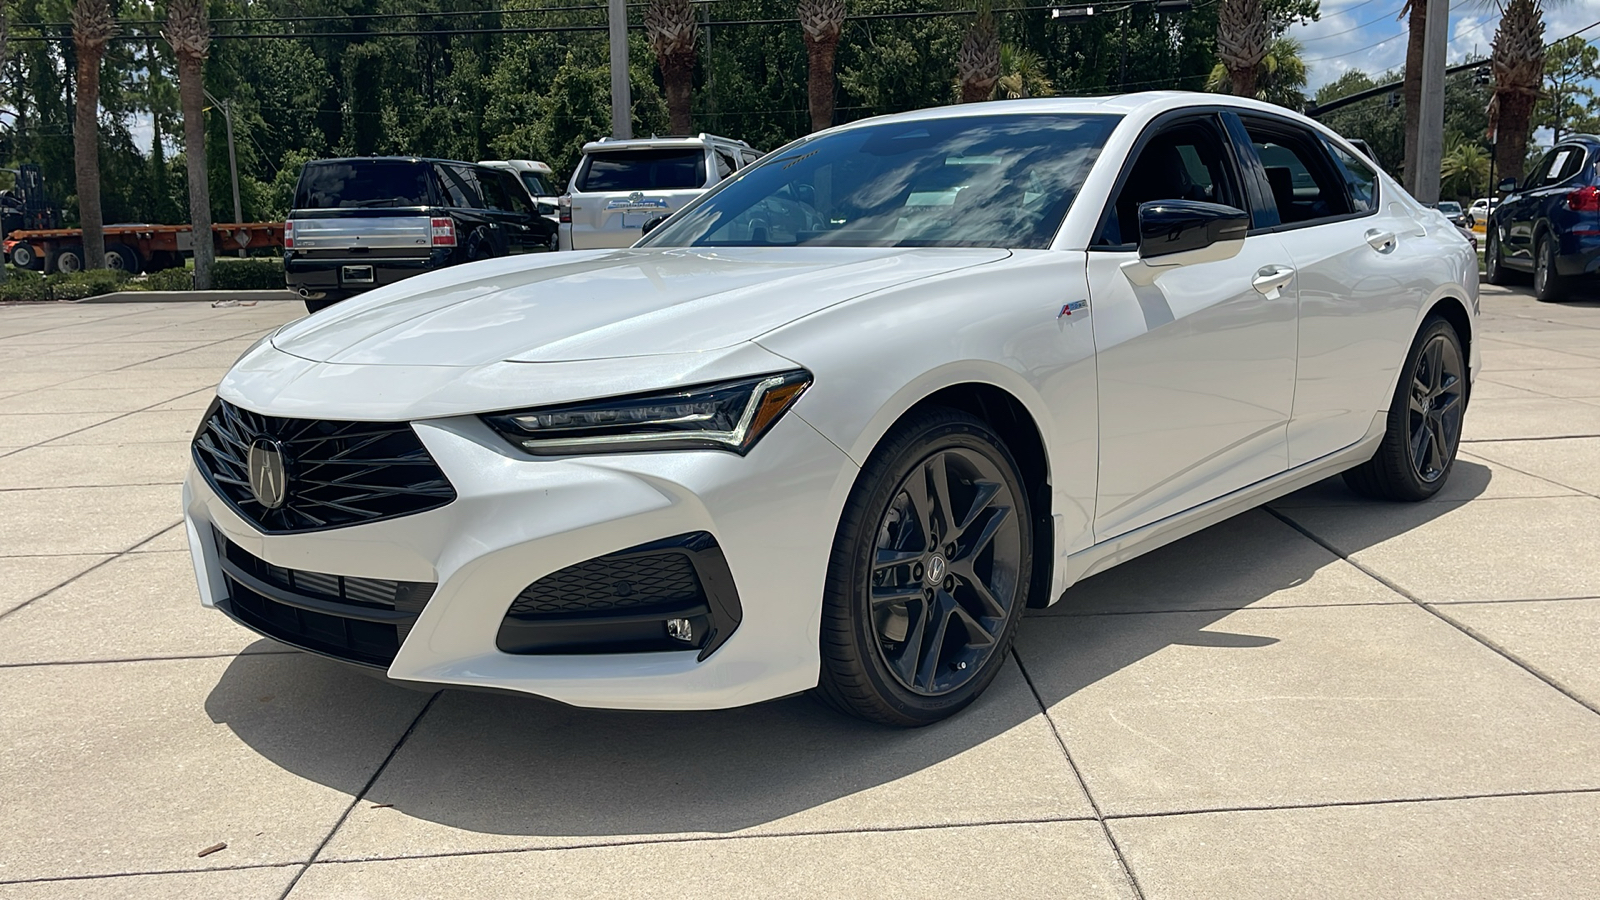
643 114 1117 248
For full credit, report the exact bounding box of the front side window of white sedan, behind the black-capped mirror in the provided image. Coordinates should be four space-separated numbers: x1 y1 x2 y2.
1094 119 1250 247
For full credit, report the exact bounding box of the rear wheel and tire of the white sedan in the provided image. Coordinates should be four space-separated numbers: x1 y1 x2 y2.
1344 315 1467 501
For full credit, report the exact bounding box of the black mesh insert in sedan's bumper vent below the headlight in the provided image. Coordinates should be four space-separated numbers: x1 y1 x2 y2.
509 551 706 617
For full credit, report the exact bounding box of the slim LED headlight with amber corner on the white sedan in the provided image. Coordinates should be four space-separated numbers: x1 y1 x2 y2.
483 370 811 456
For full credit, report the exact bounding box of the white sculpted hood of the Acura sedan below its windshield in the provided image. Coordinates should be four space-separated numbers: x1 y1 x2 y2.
272 247 1010 367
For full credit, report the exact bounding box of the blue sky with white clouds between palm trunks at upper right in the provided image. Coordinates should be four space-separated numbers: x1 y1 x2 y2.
1290 0 1600 91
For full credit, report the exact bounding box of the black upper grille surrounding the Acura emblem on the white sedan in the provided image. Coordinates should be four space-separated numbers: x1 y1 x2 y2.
194 399 456 533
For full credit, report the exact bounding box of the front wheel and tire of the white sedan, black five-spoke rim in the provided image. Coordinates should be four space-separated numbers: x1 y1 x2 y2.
818 408 1035 727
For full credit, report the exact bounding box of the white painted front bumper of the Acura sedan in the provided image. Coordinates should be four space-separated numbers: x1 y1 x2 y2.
184 412 856 709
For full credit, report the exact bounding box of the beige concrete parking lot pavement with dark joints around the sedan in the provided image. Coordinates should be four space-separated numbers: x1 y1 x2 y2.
0 287 1600 900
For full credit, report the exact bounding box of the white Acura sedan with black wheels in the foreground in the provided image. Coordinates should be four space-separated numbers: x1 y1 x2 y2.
184 93 1478 725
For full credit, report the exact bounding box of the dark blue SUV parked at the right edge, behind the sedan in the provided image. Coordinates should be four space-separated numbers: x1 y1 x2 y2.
1483 135 1600 301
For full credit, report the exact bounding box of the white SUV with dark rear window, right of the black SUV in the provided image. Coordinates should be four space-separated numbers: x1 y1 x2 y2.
560 133 762 250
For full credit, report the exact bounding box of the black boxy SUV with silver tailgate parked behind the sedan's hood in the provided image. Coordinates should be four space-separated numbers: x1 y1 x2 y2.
283 157 557 312
